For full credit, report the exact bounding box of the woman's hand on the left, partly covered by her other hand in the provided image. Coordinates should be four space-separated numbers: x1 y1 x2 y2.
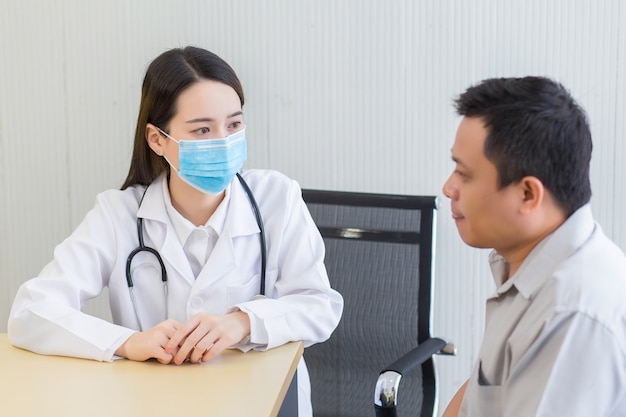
115 319 181 364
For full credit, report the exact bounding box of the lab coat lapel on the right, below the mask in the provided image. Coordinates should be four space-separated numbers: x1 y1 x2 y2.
197 179 261 284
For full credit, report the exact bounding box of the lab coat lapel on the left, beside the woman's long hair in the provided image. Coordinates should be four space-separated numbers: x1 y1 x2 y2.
137 174 195 284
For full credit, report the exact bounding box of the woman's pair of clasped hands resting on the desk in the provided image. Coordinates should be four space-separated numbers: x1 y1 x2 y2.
115 311 250 365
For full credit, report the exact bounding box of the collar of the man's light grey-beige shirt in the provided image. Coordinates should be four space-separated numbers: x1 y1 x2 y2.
489 204 595 299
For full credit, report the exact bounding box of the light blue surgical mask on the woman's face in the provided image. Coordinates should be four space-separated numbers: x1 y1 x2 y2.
159 128 247 194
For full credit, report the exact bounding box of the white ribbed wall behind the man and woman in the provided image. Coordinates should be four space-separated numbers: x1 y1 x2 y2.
0 0 626 414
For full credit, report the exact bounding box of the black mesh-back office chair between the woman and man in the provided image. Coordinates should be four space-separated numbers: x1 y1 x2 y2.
303 189 454 417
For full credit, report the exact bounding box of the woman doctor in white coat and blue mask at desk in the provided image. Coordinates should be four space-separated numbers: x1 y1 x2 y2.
8 47 343 416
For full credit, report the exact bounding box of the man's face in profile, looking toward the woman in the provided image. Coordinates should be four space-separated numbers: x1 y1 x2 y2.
443 117 521 252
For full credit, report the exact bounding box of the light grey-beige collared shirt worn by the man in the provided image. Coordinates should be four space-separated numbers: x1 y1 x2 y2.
459 206 626 417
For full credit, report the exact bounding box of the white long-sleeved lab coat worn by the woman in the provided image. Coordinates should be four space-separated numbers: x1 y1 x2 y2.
8 170 343 415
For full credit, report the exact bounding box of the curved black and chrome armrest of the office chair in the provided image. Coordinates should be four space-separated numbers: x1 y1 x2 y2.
374 337 456 417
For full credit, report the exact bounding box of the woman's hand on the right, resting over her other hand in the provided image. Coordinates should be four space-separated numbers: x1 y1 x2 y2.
165 311 250 365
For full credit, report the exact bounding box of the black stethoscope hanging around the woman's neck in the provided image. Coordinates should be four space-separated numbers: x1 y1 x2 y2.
126 173 267 331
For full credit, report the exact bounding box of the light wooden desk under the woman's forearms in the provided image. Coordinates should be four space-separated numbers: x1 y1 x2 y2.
0 334 303 417
